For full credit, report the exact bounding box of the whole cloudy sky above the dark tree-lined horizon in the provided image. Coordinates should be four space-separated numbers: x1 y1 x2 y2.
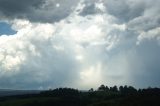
0 0 160 89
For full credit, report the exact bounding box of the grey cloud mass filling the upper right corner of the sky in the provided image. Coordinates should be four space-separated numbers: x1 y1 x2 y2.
104 0 160 31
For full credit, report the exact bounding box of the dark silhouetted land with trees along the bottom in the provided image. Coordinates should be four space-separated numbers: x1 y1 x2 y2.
0 85 160 106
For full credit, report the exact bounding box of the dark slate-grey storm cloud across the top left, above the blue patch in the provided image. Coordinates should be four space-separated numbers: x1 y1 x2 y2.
0 0 79 22
